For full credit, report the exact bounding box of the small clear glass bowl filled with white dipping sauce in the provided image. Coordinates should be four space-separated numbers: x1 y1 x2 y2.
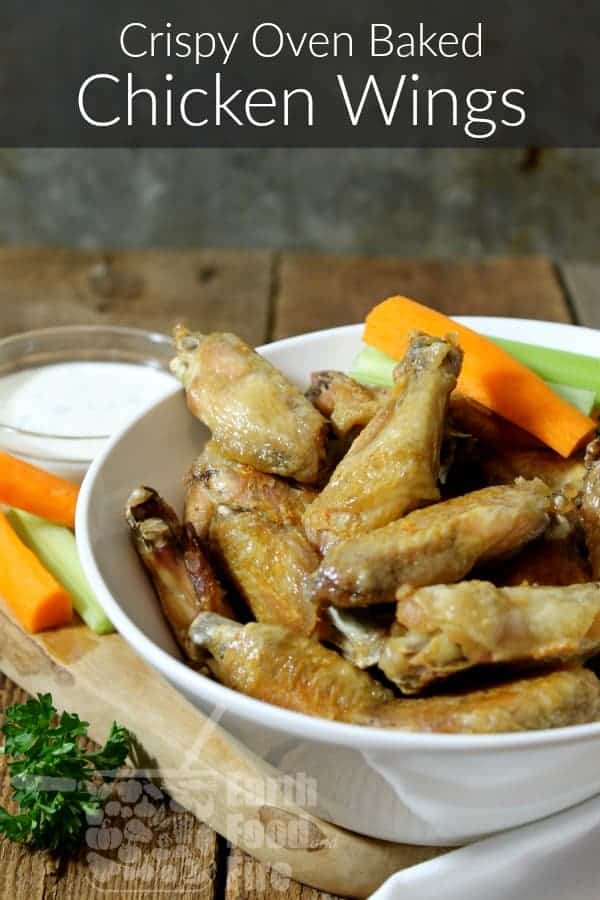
0 325 177 482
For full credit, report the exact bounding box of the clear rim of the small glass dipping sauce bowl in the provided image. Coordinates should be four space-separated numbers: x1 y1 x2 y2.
0 325 173 442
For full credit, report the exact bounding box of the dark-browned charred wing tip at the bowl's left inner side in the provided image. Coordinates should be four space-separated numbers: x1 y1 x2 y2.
126 487 233 661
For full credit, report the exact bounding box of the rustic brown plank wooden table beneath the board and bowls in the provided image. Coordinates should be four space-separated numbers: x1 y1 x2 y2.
0 248 600 900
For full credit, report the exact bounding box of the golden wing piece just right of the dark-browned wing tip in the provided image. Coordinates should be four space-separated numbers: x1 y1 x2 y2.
210 508 319 635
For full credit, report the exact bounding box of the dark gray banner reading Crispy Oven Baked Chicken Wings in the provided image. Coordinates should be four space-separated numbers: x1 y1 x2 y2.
0 0 600 147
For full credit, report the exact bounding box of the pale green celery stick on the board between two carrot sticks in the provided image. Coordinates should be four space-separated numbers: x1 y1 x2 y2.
7 509 114 634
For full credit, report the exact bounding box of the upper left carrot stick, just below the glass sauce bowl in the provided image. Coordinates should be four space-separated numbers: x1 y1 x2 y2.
0 452 79 528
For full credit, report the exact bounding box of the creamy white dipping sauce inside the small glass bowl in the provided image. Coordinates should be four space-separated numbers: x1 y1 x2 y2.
0 362 174 437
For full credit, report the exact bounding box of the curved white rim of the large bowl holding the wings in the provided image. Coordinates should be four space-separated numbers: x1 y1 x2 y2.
76 316 600 753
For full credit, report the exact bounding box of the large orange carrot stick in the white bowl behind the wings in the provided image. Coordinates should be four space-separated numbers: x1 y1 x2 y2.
364 297 595 456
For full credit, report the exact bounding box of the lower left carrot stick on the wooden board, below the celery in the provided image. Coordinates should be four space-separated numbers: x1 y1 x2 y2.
0 512 72 633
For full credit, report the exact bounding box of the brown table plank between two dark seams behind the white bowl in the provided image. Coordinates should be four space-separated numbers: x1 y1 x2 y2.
273 254 570 339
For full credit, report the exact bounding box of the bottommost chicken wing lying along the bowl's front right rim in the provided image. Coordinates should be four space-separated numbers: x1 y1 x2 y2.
354 668 600 734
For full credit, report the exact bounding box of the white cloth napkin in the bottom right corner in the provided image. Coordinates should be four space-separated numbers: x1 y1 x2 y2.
370 797 600 900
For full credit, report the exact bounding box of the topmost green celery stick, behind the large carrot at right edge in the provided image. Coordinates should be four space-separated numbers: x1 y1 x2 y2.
490 337 600 403
